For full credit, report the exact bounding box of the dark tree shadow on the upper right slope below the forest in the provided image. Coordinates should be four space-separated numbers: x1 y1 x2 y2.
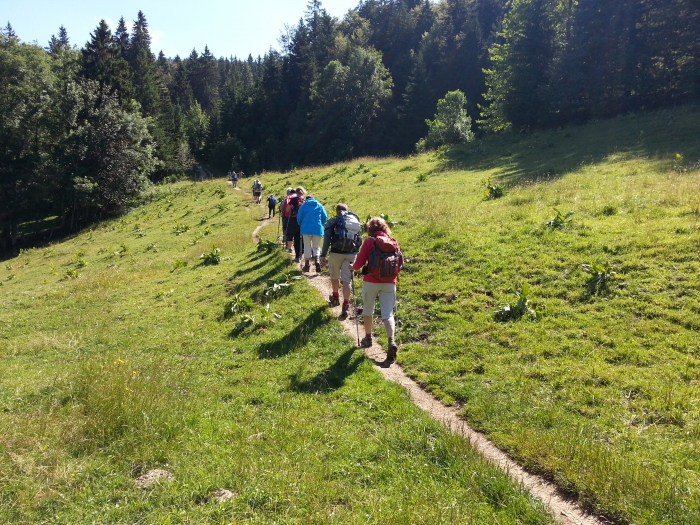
434 105 700 184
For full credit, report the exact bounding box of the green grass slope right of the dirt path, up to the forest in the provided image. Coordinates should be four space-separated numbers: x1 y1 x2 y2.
254 107 700 525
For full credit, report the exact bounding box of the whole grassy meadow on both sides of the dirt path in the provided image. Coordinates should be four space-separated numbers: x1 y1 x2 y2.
0 107 700 525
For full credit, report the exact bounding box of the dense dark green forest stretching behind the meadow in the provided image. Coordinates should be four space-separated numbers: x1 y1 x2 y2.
0 0 700 247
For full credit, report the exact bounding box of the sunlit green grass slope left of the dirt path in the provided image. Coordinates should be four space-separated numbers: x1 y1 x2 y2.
0 182 552 525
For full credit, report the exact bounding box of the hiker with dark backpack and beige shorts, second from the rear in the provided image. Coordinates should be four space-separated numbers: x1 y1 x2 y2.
321 202 362 320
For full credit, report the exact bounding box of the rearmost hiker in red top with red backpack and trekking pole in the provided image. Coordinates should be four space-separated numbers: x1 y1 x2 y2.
352 217 403 362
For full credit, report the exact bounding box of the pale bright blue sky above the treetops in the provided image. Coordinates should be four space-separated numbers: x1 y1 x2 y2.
5 0 359 58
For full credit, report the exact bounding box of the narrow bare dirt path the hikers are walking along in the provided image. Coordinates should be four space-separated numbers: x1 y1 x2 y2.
253 219 611 525
